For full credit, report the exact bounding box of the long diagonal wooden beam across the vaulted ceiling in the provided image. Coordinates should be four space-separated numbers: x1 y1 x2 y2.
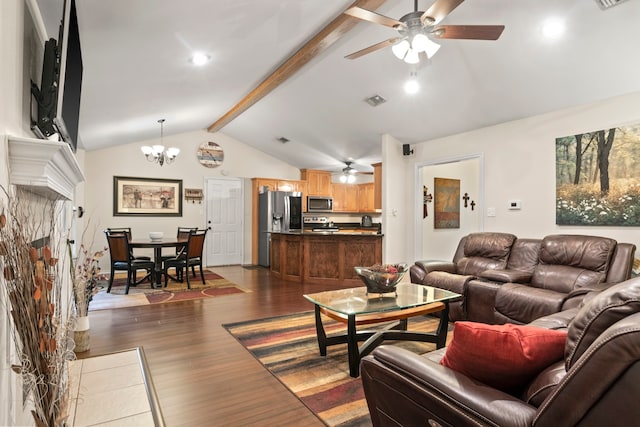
207 0 386 132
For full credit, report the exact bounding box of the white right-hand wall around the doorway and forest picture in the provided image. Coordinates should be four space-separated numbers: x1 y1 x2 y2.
382 92 640 262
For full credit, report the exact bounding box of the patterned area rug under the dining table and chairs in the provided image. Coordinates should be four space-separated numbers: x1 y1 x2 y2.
89 269 250 311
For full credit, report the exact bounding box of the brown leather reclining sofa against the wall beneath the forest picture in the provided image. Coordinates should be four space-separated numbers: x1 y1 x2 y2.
410 233 636 324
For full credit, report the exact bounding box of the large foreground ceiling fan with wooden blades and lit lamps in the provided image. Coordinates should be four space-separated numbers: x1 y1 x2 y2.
344 0 504 64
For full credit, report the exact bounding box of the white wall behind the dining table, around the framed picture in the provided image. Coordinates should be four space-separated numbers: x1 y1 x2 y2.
84 129 300 269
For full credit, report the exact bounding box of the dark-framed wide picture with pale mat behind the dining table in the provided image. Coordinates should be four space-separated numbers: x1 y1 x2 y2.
113 176 182 216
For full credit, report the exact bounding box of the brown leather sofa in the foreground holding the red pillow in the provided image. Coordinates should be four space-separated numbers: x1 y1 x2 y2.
361 278 640 427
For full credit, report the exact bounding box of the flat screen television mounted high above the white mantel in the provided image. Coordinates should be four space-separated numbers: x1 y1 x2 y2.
36 0 83 152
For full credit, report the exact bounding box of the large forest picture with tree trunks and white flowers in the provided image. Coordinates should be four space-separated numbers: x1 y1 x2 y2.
556 124 640 226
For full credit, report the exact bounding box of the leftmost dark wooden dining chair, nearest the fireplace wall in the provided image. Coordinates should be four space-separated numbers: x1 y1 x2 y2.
105 231 155 295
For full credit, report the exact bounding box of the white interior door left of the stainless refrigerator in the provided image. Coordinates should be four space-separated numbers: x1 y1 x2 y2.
206 178 244 266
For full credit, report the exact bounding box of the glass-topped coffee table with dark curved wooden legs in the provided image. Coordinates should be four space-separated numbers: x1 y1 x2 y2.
304 283 461 377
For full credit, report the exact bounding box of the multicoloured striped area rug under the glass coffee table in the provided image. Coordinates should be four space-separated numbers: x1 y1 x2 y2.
223 311 450 427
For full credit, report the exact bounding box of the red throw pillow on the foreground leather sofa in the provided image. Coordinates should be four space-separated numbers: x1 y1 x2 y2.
440 322 567 393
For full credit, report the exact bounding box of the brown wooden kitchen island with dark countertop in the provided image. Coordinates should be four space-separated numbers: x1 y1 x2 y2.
271 231 383 287
